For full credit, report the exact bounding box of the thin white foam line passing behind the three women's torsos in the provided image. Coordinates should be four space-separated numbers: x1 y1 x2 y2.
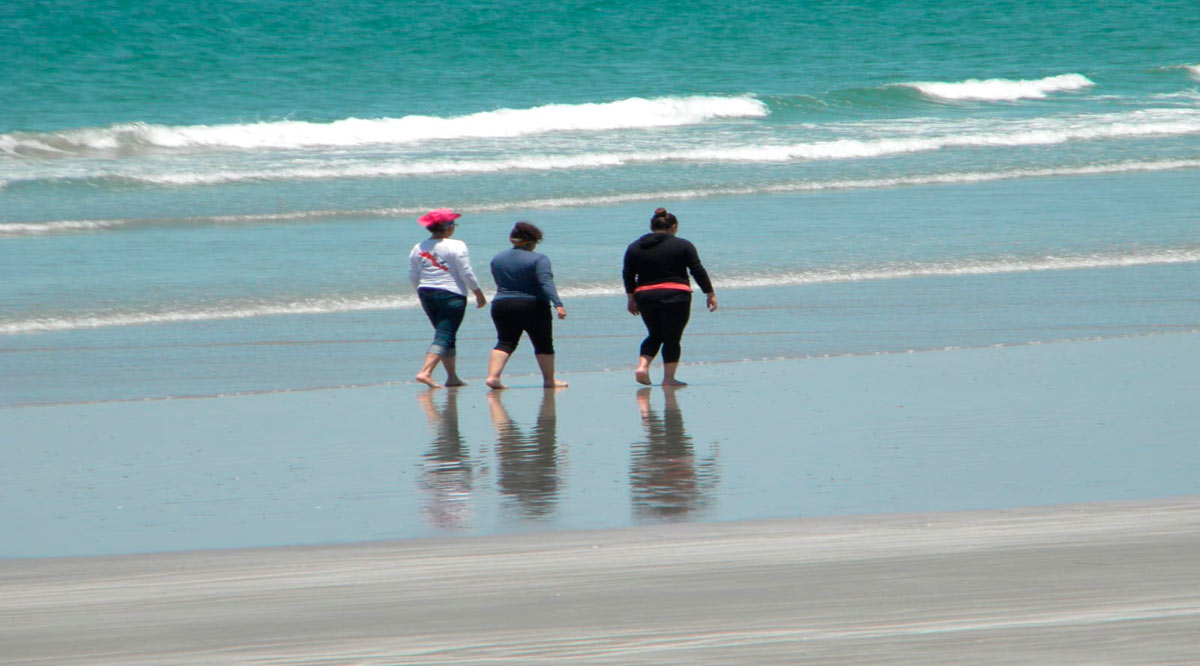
0 248 1200 335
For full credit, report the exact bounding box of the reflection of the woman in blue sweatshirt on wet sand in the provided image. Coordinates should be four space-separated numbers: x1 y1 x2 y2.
487 389 562 518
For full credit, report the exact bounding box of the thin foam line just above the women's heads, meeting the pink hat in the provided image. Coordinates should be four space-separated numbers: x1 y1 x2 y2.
0 160 1200 238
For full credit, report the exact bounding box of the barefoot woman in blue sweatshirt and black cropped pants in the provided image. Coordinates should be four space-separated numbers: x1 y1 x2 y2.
486 221 566 389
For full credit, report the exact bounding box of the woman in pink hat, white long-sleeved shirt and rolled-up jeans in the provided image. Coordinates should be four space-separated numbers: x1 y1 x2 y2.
408 208 487 389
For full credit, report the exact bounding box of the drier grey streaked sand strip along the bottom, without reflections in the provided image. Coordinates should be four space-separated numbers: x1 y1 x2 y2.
0 497 1200 665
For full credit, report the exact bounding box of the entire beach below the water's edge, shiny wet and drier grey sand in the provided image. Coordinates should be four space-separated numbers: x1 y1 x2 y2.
0 334 1200 665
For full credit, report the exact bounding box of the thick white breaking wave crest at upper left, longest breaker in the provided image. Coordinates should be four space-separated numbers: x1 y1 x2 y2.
0 95 768 154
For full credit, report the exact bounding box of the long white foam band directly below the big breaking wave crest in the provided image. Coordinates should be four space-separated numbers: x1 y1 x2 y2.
7 104 1200 193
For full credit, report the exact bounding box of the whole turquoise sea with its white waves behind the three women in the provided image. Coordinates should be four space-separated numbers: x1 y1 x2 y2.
0 0 1200 556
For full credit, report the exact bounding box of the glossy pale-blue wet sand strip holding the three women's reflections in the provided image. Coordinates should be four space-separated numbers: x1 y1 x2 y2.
0 334 1200 557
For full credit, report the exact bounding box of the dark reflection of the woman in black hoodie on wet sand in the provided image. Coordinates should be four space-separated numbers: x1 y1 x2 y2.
629 386 720 521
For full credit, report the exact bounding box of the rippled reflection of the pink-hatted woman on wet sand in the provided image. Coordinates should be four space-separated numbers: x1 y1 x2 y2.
416 389 474 528
